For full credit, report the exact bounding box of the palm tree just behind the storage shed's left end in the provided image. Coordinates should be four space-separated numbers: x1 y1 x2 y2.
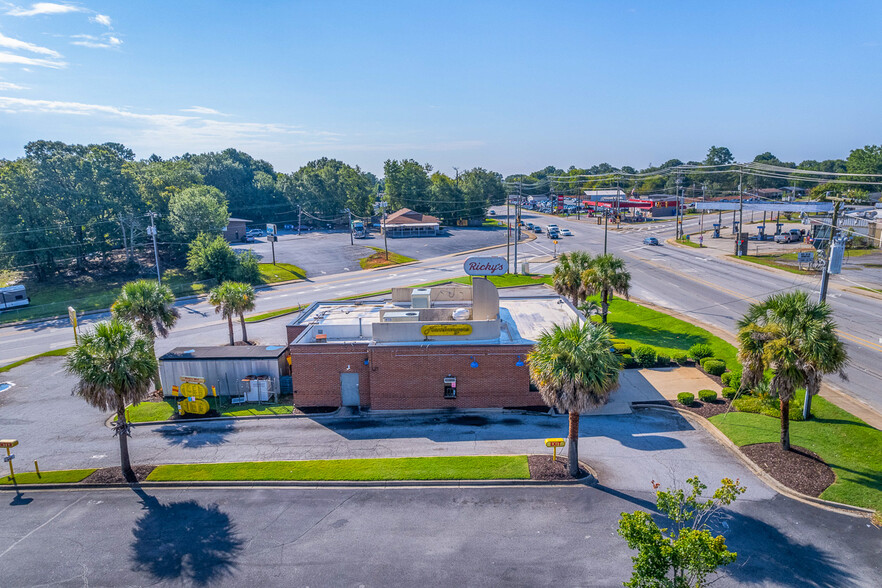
110 280 181 390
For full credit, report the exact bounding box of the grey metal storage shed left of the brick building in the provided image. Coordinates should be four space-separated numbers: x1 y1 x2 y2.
159 345 291 396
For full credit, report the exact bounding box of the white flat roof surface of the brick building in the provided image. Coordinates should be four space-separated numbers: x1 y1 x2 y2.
290 295 579 347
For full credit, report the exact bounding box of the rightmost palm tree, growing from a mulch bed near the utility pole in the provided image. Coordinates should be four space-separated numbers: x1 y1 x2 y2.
737 290 848 451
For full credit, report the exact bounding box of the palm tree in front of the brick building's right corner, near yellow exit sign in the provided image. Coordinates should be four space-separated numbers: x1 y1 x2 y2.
527 321 622 477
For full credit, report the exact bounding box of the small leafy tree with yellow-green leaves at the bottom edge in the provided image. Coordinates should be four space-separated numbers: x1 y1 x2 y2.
618 477 747 588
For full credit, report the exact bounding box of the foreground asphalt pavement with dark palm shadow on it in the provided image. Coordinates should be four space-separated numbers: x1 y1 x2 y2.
0 485 882 588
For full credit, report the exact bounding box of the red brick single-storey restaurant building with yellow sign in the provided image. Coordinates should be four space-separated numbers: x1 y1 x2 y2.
287 278 579 410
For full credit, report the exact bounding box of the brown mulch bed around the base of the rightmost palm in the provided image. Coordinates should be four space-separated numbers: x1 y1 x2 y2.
741 443 836 497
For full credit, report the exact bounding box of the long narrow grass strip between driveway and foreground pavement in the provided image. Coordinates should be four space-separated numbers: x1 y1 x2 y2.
147 455 530 481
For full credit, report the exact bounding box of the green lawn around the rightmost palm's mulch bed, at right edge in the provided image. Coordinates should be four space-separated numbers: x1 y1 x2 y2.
710 397 882 510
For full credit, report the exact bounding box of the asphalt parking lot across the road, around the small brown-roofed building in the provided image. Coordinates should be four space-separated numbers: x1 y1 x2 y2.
233 227 506 276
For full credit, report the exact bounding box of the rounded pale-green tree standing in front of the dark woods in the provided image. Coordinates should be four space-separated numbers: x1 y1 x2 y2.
168 186 230 243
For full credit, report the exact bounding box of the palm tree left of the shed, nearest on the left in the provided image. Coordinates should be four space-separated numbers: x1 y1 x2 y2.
65 318 157 482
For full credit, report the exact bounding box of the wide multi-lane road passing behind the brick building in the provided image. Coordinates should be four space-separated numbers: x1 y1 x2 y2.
0 208 882 412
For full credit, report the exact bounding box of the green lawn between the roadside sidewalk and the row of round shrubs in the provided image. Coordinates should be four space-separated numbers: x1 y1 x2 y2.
589 296 738 369
